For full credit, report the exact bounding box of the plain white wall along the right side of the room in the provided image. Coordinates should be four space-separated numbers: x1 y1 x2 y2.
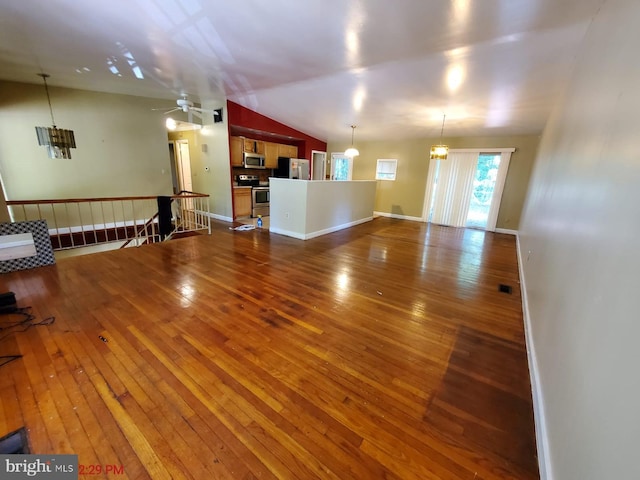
520 0 640 480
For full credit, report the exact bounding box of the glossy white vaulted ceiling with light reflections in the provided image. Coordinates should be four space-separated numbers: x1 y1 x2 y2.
0 0 604 143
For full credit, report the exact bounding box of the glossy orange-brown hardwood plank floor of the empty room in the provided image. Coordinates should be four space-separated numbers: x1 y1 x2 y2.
0 218 538 480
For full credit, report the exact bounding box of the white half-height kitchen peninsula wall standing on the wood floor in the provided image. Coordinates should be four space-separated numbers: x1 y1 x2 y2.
269 178 377 240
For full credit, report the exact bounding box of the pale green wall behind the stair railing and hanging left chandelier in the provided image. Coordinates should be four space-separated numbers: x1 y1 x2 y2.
0 82 178 200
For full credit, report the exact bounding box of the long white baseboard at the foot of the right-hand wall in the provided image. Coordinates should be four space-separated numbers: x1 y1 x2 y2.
516 230 553 480
